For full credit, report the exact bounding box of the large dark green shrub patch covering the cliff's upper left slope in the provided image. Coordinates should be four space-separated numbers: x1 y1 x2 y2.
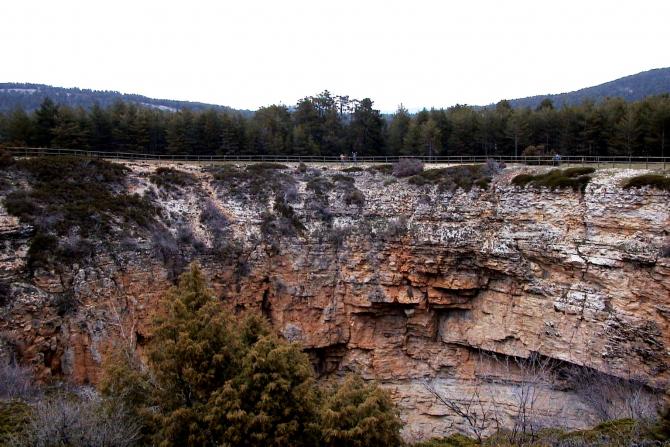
4 157 155 267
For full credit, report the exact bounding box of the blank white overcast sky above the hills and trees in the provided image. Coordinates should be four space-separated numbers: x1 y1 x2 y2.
0 0 670 112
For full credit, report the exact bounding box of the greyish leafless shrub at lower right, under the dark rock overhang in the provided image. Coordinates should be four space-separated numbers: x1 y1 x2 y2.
567 367 661 422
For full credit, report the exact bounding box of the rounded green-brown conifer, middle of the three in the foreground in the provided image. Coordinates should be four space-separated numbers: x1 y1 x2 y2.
209 335 326 447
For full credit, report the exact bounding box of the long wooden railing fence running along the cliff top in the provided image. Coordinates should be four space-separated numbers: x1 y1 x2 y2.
7 147 670 169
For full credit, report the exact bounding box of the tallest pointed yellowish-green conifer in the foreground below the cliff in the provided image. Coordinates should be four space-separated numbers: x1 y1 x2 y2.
148 264 242 446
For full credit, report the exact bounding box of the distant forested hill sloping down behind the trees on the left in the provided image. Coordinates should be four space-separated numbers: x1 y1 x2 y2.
0 82 252 115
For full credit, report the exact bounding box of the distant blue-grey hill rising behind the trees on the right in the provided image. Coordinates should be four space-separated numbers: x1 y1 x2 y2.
509 67 670 109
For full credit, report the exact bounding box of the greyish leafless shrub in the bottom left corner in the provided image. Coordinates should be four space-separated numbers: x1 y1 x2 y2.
9 393 142 447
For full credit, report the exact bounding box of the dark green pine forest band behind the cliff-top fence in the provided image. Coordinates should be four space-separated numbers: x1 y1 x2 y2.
0 91 670 156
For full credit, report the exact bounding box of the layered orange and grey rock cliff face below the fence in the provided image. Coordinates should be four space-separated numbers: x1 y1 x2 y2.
0 163 670 439
